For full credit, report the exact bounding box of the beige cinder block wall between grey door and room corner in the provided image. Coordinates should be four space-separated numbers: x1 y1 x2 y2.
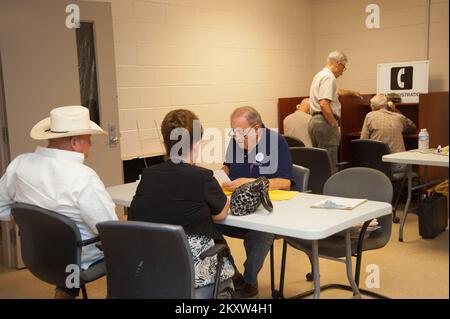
100 0 313 160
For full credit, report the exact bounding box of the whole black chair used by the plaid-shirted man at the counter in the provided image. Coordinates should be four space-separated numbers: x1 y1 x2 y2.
350 139 418 223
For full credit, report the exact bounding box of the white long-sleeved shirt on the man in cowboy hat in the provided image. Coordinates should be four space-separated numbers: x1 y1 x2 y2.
0 146 117 269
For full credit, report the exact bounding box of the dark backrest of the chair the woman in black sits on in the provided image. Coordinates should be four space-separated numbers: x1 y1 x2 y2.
97 221 195 299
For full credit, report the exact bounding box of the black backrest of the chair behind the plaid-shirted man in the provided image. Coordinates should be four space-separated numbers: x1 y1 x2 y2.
350 139 392 178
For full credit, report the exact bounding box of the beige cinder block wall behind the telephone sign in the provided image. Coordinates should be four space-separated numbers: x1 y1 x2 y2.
312 0 449 93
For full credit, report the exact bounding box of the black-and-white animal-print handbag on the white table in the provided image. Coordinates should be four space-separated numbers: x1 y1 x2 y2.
231 176 273 216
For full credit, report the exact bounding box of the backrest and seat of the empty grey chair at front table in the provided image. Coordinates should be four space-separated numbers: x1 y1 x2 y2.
323 167 393 250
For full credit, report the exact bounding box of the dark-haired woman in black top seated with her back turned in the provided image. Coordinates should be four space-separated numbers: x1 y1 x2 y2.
128 109 234 288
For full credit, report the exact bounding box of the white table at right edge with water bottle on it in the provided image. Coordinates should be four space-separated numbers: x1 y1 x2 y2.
382 150 448 241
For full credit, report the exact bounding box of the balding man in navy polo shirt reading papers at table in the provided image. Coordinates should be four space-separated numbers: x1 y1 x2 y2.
220 106 294 298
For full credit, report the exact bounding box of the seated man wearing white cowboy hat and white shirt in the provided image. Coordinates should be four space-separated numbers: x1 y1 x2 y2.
0 106 117 298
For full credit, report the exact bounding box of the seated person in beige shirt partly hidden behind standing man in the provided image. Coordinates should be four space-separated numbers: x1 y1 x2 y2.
283 98 312 147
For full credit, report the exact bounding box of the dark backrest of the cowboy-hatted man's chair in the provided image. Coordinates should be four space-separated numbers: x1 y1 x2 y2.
11 203 81 287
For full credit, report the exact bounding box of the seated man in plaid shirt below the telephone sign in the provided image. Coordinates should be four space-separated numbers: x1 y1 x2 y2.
360 94 416 172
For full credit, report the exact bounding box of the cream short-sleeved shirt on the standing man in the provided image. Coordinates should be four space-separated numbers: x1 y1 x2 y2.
309 68 341 117
